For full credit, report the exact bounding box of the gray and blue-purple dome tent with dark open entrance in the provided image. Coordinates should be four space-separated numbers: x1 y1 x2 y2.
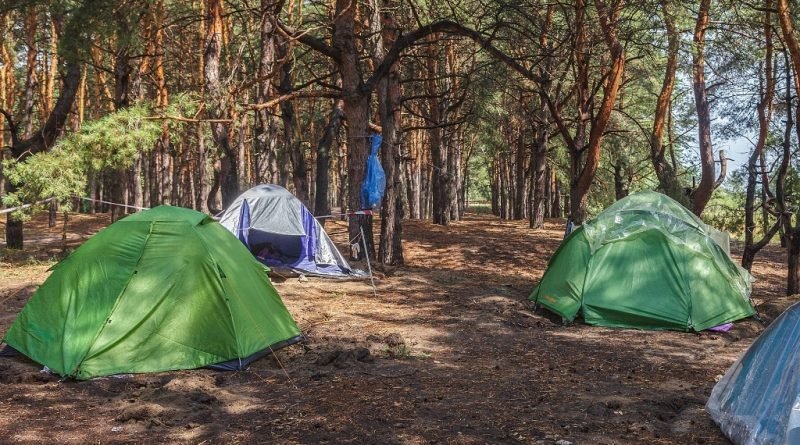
219 185 363 277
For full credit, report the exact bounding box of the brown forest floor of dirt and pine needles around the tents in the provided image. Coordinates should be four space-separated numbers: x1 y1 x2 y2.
0 214 793 445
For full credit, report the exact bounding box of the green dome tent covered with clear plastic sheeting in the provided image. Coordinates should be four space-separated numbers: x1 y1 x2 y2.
530 191 755 331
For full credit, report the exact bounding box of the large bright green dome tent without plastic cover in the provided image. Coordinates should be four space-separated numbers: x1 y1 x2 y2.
4 206 300 379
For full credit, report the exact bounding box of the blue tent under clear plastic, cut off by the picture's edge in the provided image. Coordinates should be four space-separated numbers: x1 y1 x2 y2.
706 303 800 445
